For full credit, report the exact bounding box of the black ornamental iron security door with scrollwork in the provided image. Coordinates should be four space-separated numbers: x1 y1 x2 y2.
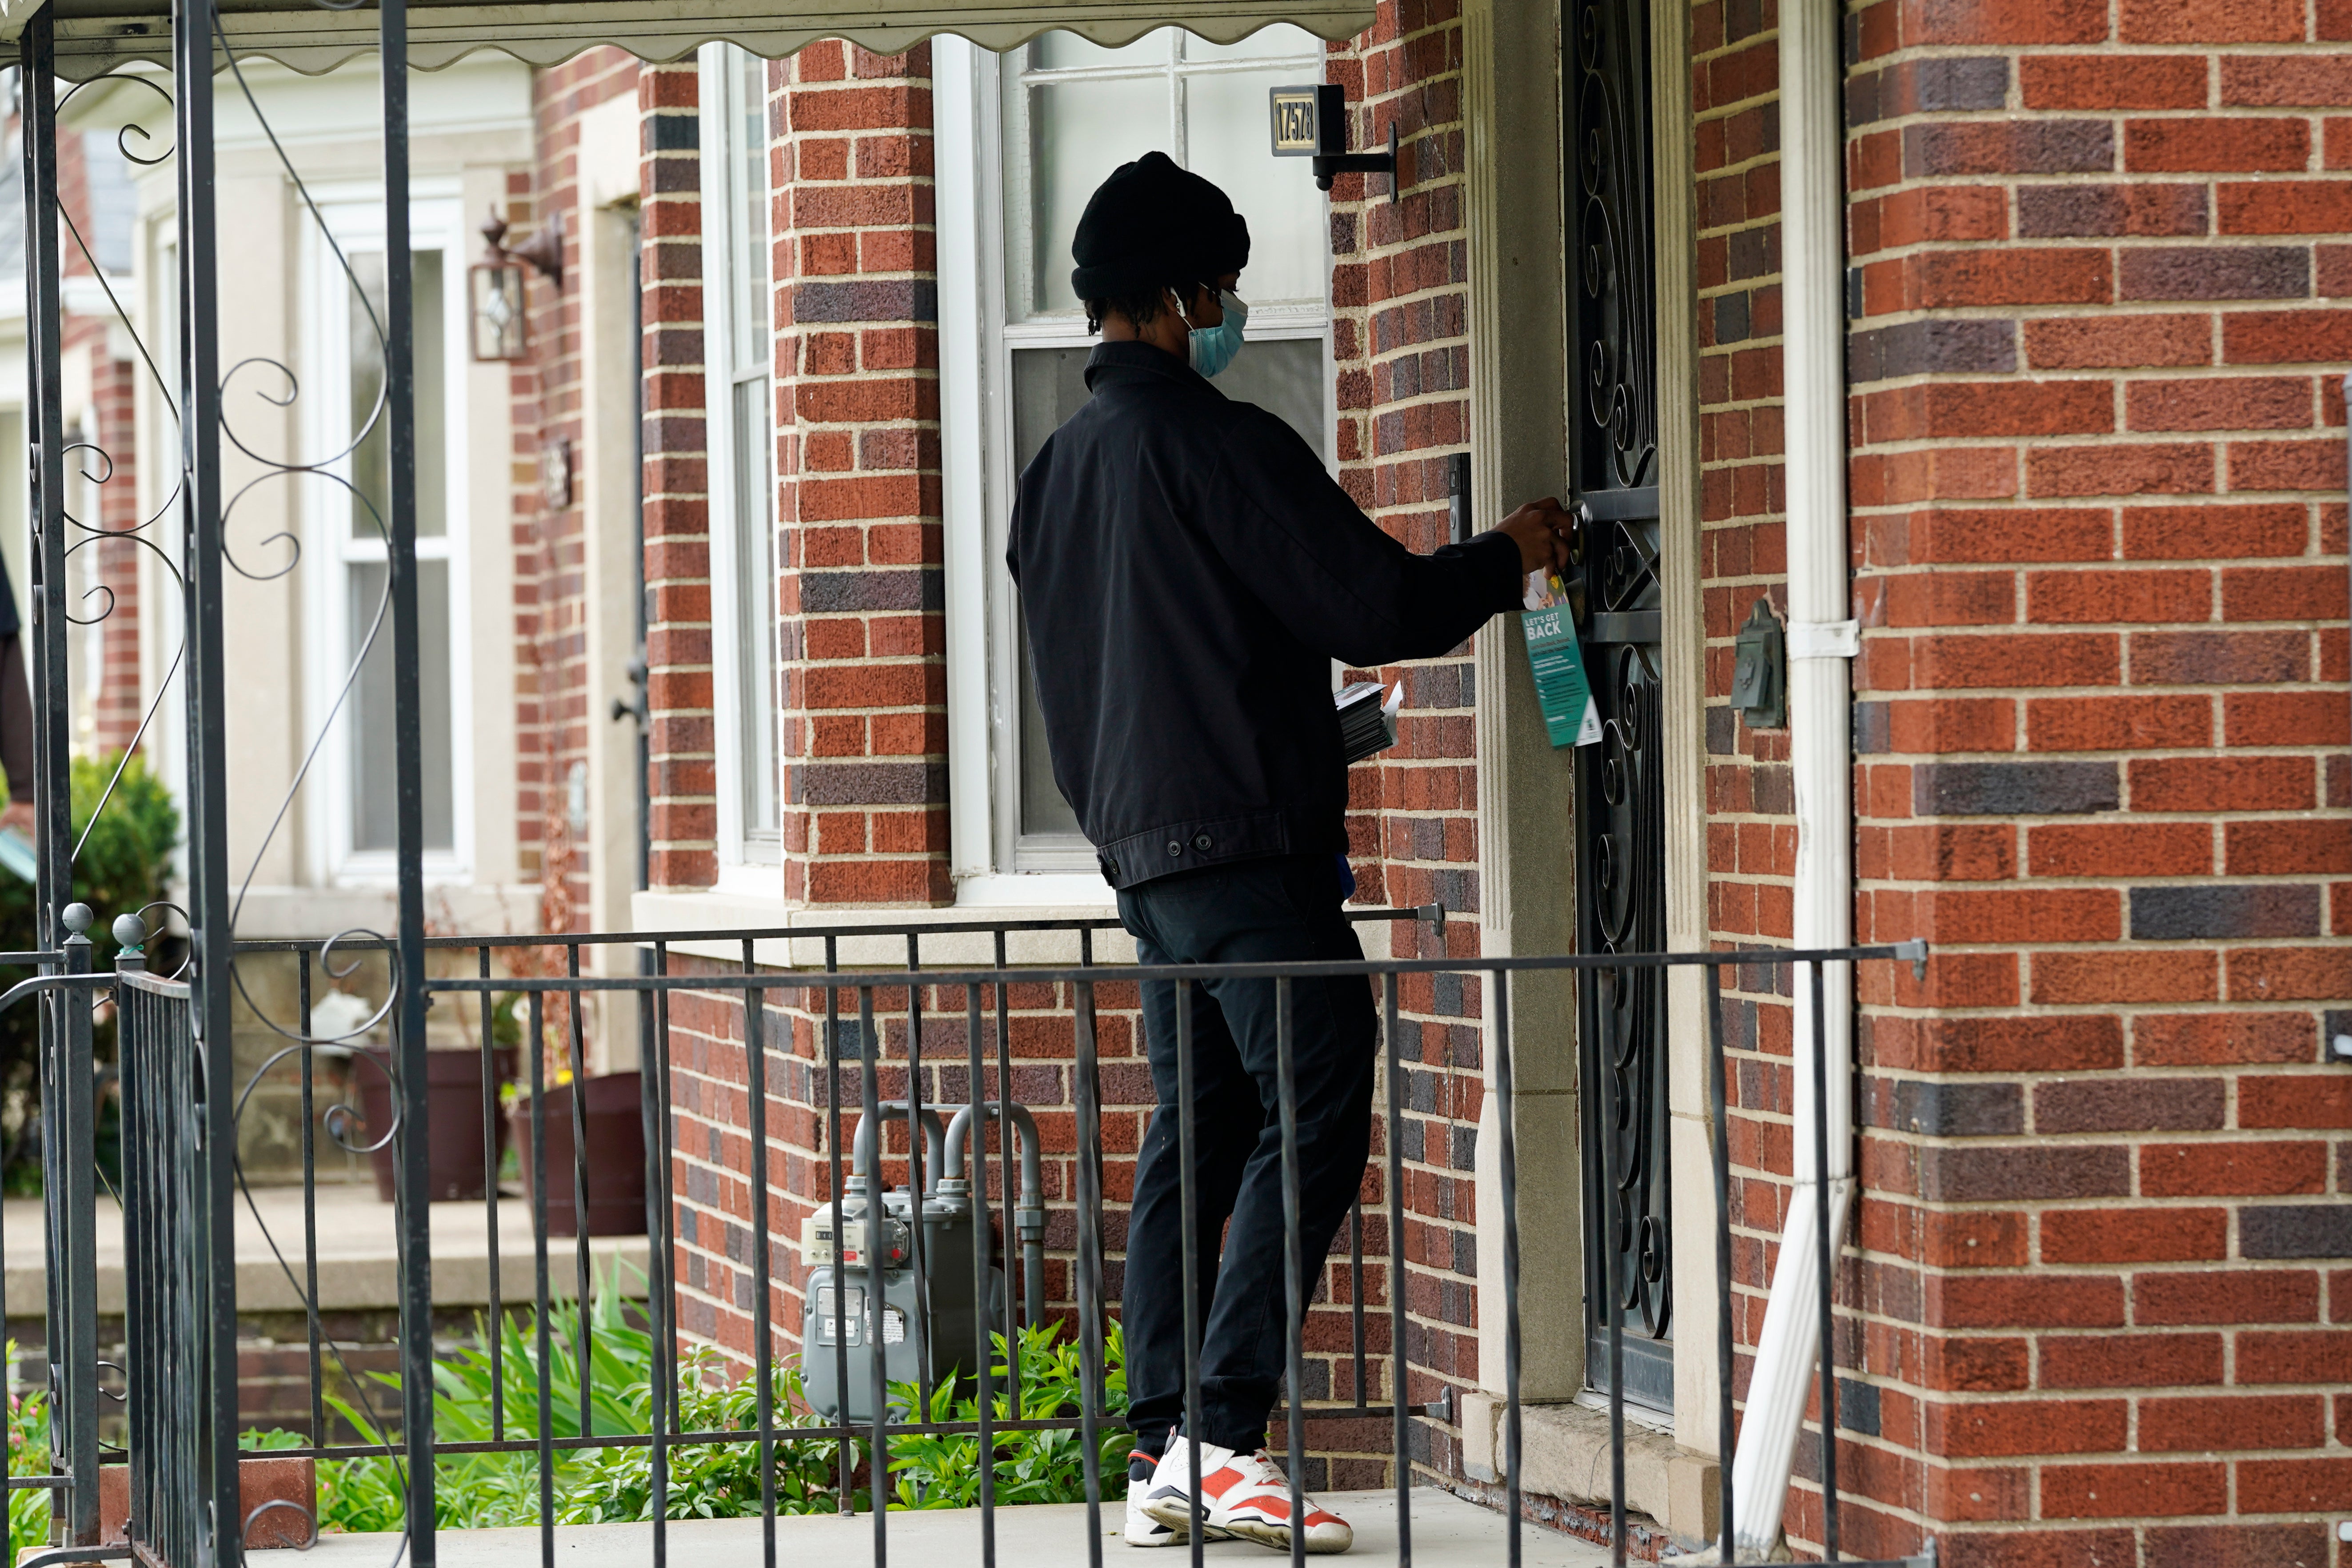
1562 0 1675 1411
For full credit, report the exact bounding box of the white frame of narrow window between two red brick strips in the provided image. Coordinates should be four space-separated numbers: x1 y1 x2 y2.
696 42 786 898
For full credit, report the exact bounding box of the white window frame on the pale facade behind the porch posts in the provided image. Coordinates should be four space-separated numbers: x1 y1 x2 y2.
299 179 475 886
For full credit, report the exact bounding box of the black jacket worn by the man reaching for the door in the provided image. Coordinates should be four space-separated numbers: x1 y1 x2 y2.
1004 343 1519 889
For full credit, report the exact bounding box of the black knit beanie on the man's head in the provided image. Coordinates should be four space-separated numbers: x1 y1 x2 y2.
1070 153 1249 299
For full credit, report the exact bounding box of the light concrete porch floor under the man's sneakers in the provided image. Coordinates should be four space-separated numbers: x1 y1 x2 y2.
244 1488 1609 1568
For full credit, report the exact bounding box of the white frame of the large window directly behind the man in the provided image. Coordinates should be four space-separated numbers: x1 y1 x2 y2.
931 31 1338 905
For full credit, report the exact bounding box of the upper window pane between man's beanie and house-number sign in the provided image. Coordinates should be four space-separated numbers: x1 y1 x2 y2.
1186 68 1326 303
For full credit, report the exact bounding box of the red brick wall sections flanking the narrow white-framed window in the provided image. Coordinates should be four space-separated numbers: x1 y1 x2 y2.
644 40 953 907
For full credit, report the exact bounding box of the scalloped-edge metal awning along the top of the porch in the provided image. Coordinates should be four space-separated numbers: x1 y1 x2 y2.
0 0 1374 80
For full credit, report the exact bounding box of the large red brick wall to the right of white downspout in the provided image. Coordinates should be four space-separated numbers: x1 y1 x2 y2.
1834 0 2352 1568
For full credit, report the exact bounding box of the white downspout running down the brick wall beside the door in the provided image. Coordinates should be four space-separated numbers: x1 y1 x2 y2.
1731 0 1856 1554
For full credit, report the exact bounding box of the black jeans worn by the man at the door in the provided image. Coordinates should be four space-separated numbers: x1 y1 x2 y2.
1119 856 1376 1453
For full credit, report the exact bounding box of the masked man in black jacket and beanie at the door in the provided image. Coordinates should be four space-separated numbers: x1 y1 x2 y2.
1006 153 1569 1552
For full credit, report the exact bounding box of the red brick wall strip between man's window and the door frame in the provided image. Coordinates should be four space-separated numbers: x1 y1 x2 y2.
1326 0 1493 1484
